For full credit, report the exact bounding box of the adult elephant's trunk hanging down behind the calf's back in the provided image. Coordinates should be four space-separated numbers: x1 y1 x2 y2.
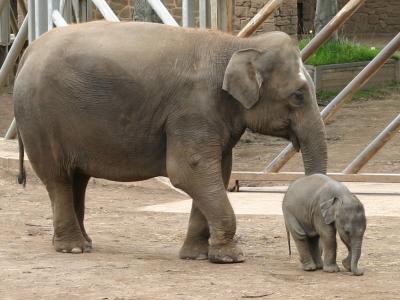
294 112 328 175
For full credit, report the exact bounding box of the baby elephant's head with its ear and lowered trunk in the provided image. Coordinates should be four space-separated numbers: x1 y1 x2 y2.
320 193 367 275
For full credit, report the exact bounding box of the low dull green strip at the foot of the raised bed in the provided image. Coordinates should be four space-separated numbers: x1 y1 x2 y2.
317 82 400 105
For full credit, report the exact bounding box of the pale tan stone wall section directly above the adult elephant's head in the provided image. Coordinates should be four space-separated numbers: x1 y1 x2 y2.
234 0 297 35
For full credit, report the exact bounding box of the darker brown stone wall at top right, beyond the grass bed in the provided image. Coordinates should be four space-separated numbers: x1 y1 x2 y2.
302 0 400 36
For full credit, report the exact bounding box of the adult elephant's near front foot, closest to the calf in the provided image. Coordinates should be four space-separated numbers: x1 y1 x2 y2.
208 242 244 264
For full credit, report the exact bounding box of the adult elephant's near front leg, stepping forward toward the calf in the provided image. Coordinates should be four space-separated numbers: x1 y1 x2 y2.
167 135 244 263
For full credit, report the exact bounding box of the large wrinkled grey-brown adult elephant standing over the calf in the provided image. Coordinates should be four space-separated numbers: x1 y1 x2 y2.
14 22 327 263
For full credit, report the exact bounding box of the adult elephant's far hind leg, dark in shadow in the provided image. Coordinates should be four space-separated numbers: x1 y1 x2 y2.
73 173 92 252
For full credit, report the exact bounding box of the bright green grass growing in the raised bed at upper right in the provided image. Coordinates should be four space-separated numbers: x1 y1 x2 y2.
299 38 400 66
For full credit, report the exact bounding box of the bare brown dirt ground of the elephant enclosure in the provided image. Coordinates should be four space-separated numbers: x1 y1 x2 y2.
0 90 400 300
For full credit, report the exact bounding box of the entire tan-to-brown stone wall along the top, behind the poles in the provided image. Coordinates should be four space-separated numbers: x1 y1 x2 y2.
107 0 400 36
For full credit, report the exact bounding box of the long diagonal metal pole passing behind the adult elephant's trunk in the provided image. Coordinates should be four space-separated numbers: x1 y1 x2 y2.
264 33 400 172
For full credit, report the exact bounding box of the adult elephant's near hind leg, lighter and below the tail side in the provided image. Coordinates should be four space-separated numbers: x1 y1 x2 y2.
46 178 86 253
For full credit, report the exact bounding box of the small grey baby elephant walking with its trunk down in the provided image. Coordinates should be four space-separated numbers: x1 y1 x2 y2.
282 174 367 275
